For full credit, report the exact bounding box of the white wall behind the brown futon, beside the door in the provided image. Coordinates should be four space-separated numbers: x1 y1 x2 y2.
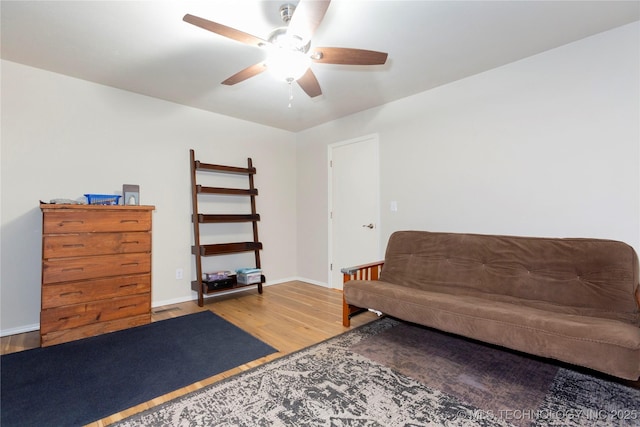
297 23 640 283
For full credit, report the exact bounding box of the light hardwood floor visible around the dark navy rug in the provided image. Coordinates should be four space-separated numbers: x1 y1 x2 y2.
0 281 377 427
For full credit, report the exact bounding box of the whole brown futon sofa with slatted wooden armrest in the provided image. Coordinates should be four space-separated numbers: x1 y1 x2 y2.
342 231 640 380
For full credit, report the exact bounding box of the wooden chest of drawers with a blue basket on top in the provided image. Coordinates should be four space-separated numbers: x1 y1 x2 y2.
40 204 155 347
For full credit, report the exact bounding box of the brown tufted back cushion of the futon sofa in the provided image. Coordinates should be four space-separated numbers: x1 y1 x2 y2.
380 231 639 318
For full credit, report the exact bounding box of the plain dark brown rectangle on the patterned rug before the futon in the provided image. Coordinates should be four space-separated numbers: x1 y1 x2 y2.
351 323 559 425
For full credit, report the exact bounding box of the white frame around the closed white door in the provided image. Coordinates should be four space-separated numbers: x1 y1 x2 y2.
327 133 381 289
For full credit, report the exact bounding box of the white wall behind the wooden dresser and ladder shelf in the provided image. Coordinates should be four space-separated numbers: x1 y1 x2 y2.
0 61 296 335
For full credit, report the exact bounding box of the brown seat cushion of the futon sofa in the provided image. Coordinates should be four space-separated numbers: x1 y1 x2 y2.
344 280 640 380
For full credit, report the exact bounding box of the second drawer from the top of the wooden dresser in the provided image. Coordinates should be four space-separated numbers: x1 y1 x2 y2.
42 232 151 259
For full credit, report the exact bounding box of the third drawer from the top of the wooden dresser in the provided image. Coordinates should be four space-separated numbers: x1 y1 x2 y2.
42 253 151 285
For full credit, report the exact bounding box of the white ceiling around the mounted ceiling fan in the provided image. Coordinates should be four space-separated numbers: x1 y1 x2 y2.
0 0 640 131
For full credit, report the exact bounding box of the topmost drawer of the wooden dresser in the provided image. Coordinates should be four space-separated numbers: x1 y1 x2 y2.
42 210 151 234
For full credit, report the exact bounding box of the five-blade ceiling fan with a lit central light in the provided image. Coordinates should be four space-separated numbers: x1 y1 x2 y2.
183 0 387 98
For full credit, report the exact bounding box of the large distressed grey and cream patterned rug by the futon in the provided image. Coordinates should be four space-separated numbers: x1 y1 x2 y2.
118 318 640 426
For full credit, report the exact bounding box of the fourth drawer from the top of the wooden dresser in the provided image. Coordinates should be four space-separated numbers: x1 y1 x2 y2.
42 274 151 310
